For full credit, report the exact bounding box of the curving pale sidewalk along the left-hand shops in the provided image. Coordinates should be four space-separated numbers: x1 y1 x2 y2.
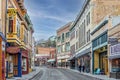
6 67 41 80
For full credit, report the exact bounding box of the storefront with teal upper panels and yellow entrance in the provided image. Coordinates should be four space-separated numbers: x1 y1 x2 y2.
92 32 109 75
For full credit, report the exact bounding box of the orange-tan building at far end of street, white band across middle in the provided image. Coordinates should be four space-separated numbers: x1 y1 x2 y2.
35 47 54 66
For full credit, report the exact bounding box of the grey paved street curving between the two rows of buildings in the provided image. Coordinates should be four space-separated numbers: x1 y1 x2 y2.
32 68 98 80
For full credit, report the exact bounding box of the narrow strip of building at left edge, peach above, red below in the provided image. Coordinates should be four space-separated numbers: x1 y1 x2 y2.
0 0 6 80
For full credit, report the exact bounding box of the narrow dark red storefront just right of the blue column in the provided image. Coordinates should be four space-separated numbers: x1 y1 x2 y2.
21 50 29 74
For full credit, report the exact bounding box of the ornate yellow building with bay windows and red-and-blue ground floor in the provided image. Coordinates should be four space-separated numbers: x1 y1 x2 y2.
6 0 34 78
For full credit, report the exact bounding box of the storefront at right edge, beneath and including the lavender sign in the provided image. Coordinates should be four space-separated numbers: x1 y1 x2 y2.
109 43 120 79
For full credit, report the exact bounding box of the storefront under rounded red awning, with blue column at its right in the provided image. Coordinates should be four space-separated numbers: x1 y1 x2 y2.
6 47 22 77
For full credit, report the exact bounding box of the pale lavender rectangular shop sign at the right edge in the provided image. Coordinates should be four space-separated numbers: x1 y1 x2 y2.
110 43 120 56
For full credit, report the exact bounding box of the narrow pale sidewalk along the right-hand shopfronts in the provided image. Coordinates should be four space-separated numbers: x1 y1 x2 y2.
69 69 120 80
